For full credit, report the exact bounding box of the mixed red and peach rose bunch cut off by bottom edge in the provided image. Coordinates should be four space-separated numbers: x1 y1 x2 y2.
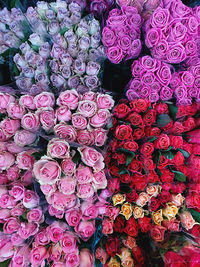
95 235 144 267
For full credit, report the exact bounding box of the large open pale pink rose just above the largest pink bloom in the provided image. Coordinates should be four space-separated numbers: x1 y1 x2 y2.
47 138 70 159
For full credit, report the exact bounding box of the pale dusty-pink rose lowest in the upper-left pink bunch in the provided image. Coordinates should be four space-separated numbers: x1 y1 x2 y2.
14 130 36 146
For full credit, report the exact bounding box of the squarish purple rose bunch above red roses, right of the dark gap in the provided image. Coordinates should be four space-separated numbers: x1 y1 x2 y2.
126 56 173 102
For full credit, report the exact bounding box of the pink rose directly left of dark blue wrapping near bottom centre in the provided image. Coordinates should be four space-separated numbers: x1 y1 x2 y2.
75 220 95 241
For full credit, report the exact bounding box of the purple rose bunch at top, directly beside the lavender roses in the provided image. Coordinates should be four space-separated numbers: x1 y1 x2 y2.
102 6 142 64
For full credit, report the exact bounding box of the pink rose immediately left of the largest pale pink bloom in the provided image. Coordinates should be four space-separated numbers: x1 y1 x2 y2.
16 150 35 170
